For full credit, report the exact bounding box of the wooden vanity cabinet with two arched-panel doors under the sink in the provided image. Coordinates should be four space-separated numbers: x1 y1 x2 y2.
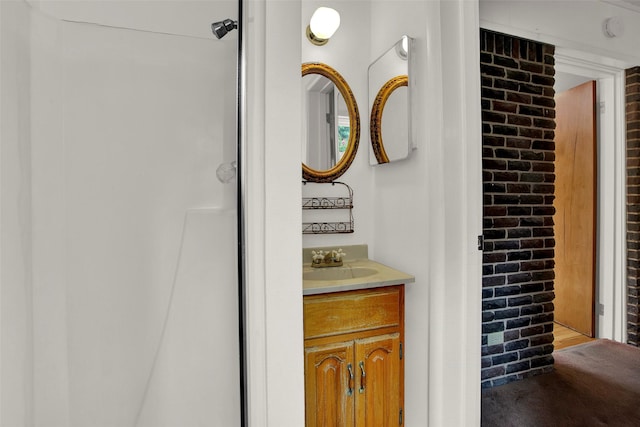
304 285 404 427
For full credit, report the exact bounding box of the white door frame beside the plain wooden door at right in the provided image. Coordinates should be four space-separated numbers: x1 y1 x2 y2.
555 48 626 342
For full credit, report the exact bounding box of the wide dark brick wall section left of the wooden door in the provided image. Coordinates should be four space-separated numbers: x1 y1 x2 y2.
480 30 555 387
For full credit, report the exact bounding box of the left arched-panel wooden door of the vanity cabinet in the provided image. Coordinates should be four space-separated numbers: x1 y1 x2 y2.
304 341 356 427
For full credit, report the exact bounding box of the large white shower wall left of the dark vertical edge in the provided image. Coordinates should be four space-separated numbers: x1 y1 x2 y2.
0 1 239 427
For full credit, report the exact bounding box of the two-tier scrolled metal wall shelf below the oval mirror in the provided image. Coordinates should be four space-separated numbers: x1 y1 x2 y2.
302 181 354 234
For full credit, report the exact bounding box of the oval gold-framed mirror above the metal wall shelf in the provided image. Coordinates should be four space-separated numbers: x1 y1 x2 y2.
302 62 360 182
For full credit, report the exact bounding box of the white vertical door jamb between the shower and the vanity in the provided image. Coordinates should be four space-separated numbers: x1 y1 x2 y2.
243 0 304 426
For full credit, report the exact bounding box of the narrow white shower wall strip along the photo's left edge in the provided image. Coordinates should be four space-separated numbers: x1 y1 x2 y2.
0 1 33 426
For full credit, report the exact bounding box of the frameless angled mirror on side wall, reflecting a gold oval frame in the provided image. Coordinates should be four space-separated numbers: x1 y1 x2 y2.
369 36 414 165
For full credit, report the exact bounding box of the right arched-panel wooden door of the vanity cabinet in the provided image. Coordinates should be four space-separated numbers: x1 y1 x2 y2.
355 333 401 427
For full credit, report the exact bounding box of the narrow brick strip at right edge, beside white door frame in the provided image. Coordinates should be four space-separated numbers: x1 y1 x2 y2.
626 67 640 346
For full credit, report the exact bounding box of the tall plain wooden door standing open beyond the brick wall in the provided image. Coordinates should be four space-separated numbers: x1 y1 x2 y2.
554 81 597 337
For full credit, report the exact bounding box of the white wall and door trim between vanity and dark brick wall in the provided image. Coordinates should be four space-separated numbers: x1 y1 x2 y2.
371 1 482 426
